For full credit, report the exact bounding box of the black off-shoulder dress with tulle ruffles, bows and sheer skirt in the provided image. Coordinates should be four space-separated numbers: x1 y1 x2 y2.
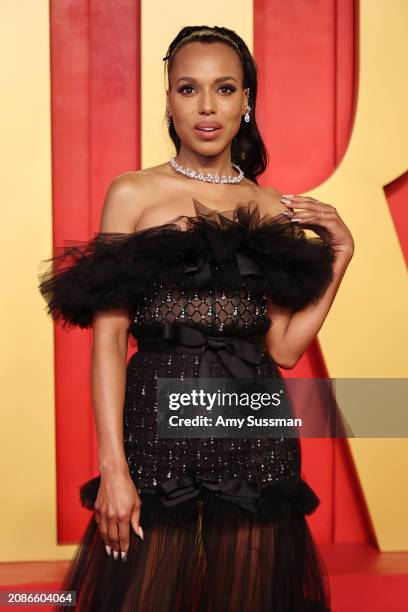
39 200 334 612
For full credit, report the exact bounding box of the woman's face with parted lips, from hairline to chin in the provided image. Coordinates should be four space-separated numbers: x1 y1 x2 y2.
167 41 247 156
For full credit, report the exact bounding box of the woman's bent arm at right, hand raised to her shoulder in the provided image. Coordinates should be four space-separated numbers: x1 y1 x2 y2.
266 196 354 369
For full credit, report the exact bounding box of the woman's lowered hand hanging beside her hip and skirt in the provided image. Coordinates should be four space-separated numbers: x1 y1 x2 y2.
95 473 143 561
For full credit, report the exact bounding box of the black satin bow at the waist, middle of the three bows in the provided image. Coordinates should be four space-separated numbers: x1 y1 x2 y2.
163 321 263 378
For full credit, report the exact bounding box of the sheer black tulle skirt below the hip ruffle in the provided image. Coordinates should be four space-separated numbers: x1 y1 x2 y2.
58 488 330 612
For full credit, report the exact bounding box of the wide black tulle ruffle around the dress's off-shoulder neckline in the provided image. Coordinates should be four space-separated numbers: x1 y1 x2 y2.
39 200 335 328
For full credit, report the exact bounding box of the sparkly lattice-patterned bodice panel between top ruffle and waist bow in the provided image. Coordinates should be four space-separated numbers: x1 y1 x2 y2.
131 282 271 337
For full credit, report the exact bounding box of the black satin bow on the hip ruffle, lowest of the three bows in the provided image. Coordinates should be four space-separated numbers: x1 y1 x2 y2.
160 475 261 512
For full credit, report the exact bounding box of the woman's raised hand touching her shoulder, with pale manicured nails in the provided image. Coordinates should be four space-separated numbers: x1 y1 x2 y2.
281 194 354 257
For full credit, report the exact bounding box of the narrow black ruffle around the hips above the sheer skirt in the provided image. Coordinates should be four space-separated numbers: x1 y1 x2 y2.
79 475 320 527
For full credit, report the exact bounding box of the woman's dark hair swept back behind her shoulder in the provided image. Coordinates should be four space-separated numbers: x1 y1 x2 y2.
163 26 268 184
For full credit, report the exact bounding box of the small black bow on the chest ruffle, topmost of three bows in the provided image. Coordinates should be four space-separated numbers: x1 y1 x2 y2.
184 251 262 287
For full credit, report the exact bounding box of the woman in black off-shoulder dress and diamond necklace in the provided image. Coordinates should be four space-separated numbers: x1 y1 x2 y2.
40 26 354 612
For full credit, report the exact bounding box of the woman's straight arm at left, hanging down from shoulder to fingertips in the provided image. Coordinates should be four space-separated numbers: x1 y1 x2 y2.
91 174 143 559
